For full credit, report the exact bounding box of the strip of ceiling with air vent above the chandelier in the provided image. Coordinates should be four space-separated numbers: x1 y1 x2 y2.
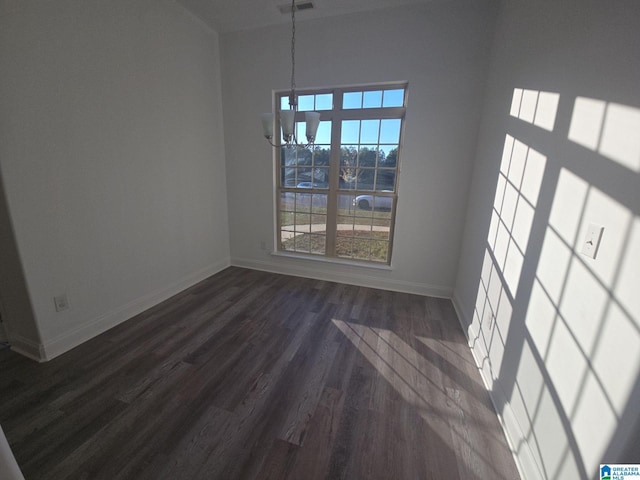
177 0 434 33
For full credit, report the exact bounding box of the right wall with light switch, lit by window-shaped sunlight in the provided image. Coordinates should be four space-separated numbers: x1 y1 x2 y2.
454 0 640 479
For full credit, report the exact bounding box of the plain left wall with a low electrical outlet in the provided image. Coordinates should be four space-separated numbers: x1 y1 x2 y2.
0 0 229 358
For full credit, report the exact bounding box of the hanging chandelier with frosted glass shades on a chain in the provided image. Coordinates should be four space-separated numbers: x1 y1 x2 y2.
260 0 320 148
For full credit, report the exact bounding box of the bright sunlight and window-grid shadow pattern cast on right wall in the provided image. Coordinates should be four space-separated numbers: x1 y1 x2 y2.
469 89 640 478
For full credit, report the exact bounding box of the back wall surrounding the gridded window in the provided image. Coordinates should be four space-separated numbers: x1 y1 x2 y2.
221 1 495 296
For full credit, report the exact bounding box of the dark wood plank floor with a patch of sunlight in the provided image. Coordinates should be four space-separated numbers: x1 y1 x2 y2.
0 268 519 480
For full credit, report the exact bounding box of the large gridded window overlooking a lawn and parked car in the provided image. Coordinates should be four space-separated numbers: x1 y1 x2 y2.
276 84 407 264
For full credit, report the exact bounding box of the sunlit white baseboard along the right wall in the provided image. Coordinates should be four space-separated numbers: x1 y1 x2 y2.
451 292 543 480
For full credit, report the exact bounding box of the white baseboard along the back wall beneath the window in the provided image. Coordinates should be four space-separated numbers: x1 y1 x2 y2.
231 257 453 298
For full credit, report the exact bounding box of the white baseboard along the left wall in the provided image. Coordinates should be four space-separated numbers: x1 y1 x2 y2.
36 259 230 362
